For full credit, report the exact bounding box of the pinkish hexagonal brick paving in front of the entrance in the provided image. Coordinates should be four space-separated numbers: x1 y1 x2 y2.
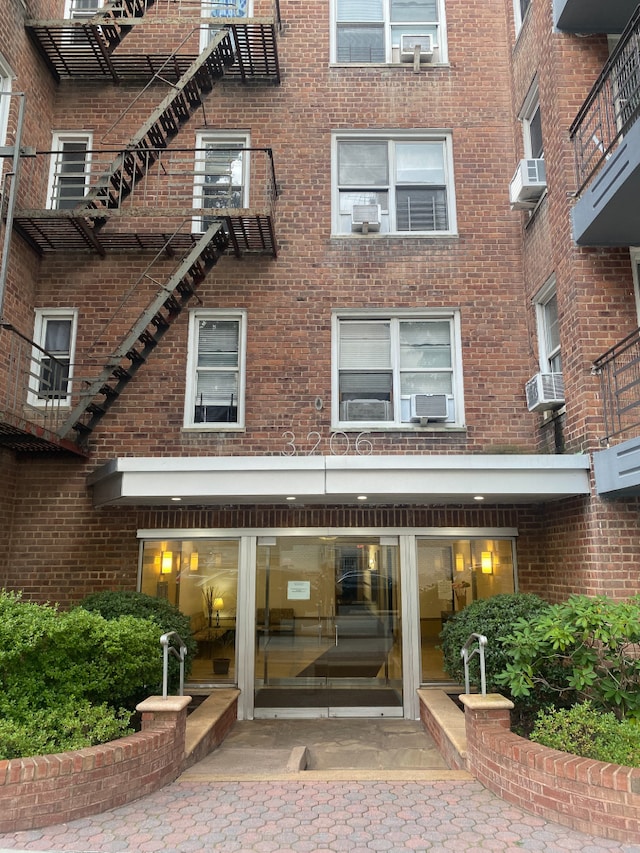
0 778 640 853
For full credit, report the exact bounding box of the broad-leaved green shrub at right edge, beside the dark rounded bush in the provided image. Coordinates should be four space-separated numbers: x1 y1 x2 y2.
498 595 640 721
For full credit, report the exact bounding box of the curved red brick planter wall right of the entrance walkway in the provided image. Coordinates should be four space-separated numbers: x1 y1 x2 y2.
460 694 640 844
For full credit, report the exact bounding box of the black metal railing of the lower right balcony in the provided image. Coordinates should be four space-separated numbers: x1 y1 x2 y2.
592 329 640 444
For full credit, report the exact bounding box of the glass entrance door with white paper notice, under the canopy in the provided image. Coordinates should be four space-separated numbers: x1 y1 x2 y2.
254 536 402 717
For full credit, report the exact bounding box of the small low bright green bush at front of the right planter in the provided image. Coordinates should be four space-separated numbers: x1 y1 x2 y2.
530 702 640 767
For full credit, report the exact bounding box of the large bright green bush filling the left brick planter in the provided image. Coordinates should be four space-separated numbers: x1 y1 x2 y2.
0 591 162 758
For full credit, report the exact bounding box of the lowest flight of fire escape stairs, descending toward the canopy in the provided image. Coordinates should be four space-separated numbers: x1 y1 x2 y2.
58 222 228 446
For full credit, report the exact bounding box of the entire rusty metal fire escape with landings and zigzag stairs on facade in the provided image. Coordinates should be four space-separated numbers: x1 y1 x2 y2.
0 0 280 450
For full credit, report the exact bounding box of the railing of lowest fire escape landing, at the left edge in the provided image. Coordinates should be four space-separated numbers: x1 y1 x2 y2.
0 323 86 453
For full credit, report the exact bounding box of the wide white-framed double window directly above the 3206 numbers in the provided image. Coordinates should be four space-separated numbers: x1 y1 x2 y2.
334 316 457 425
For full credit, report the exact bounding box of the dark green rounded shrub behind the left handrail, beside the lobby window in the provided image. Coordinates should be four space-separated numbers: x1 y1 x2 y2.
80 590 198 690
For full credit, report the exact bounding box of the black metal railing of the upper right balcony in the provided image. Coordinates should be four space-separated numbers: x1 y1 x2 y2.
569 6 640 195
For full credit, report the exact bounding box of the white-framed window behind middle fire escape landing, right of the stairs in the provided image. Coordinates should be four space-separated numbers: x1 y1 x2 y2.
193 132 249 231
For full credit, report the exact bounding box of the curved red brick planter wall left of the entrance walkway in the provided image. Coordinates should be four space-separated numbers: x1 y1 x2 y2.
0 696 191 832
